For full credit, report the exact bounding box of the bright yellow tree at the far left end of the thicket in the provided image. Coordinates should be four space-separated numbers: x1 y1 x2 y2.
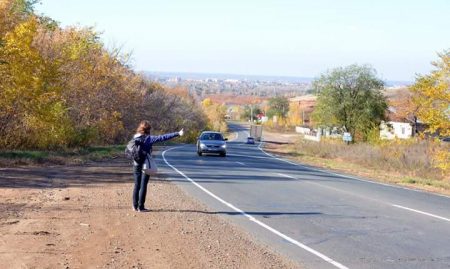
0 17 71 148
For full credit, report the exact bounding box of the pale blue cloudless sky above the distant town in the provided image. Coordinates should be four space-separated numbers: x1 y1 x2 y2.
36 0 450 81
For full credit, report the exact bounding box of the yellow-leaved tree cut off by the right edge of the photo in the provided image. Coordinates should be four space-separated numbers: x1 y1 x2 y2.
411 50 450 136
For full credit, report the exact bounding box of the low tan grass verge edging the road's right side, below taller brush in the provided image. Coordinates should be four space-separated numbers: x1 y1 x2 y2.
265 141 450 195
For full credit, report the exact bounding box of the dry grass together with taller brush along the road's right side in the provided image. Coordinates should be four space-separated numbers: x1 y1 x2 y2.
267 139 450 194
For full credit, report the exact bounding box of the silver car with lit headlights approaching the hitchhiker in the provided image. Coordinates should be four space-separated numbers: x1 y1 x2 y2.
197 131 228 157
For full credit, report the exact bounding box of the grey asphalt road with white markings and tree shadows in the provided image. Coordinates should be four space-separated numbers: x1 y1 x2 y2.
158 122 450 269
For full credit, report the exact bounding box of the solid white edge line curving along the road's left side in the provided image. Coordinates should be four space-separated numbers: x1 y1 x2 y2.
162 146 348 269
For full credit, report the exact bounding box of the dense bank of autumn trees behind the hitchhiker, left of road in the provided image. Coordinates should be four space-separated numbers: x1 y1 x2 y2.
0 0 207 149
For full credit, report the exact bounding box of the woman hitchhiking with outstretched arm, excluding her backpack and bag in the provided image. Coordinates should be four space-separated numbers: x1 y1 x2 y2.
133 120 184 212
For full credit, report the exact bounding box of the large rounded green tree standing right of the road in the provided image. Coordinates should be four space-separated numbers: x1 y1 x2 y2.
312 65 387 140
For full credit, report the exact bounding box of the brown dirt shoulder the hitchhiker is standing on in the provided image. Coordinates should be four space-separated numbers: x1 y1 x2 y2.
0 160 298 268
